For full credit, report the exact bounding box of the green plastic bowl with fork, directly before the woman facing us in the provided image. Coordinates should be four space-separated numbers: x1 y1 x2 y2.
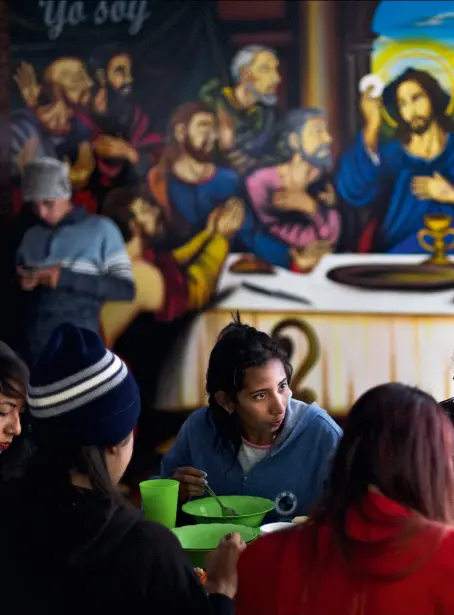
182 495 274 527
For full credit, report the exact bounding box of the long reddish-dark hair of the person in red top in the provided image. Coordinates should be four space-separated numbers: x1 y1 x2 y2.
312 382 454 576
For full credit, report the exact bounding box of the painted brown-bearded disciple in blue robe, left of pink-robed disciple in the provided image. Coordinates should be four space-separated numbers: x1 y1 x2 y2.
148 102 316 270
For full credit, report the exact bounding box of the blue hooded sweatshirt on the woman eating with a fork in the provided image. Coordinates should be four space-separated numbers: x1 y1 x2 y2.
161 399 342 522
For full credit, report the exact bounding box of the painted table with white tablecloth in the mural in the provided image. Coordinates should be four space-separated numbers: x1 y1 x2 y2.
154 254 454 414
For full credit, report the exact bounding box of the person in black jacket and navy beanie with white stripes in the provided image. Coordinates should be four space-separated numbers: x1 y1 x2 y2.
0 324 239 615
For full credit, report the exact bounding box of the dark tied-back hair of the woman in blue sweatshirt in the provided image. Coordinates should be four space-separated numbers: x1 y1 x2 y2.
206 313 292 452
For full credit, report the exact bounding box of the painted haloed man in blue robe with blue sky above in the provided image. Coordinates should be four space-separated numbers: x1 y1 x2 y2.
337 2 454 254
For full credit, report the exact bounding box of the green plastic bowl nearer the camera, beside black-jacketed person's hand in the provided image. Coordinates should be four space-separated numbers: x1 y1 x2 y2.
172 523 260 568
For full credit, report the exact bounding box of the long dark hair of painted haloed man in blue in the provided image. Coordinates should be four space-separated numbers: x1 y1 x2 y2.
383 68 454 144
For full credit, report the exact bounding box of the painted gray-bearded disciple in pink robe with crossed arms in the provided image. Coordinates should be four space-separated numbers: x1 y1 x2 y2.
246 108 340 268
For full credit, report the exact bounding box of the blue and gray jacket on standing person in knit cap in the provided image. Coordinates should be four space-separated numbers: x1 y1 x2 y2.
16 207 135 362
